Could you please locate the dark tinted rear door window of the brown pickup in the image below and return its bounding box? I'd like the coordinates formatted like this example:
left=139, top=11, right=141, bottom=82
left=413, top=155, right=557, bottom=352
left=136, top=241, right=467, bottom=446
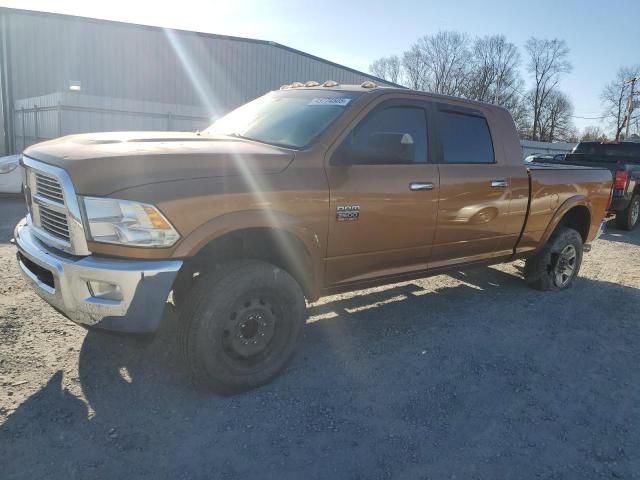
left=438, top=112, right=495, bottom=163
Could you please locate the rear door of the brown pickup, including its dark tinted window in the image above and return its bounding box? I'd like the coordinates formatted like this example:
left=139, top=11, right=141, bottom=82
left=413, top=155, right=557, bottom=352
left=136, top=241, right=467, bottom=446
left=429, top=104, right=510, bottom=268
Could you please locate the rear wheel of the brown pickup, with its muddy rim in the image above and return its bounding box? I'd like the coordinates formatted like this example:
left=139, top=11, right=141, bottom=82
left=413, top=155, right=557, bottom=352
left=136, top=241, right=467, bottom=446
left=524, top=226, right=583, bottom=291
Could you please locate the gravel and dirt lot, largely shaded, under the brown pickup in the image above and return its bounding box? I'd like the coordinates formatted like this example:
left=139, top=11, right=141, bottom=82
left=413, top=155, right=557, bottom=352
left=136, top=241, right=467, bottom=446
left=0, top=198, right=640, bottom=479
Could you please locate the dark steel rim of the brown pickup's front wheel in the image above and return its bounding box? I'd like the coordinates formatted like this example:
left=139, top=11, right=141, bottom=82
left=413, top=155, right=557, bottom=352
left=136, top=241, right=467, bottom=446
left=222, top=295, right=279, bottom=365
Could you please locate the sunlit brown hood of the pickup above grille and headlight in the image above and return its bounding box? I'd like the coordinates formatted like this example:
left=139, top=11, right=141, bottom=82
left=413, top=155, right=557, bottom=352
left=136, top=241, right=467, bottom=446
left=24, top=132, right=294, bottom=195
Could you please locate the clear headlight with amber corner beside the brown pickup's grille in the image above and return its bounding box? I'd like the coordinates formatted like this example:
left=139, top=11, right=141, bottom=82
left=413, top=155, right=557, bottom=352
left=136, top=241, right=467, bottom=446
left=81, top=197, right=180, bottom=247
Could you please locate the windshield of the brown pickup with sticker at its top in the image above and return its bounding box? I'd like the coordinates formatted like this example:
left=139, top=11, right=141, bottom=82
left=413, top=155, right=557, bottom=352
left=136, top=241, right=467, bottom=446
left=203, top=90, right=361, bottom=148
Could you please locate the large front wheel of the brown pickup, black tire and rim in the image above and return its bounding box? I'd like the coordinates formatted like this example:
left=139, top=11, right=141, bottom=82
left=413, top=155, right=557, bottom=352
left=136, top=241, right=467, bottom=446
left=180, top=260, right=306, bottom=394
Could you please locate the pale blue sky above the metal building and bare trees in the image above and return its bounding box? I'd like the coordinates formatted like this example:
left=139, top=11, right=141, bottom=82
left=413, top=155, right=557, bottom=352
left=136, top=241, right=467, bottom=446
left=0, top=0, right=640, bottom=129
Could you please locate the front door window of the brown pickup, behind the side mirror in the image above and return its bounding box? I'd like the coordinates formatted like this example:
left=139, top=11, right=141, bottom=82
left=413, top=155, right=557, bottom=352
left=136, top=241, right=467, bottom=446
left=338, top=106, right=427, bottom=165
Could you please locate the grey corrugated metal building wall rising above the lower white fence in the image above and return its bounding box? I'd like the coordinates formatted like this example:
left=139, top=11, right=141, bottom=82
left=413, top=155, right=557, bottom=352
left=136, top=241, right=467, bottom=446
left=0, top=9, right=396, bottom=154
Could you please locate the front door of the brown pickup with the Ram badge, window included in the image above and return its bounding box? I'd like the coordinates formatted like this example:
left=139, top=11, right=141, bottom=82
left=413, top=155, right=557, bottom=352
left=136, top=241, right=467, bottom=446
left=326, top=100, right=439, bottom=286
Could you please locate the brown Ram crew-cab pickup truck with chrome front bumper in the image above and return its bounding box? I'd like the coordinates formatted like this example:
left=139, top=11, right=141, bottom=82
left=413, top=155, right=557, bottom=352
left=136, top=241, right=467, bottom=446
left=15, top=82, right=612, bottom=392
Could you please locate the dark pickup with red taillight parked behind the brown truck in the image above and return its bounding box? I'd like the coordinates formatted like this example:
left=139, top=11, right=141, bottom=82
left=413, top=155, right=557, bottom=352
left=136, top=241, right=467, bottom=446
left=534, top=142, right=640, bottom=230
